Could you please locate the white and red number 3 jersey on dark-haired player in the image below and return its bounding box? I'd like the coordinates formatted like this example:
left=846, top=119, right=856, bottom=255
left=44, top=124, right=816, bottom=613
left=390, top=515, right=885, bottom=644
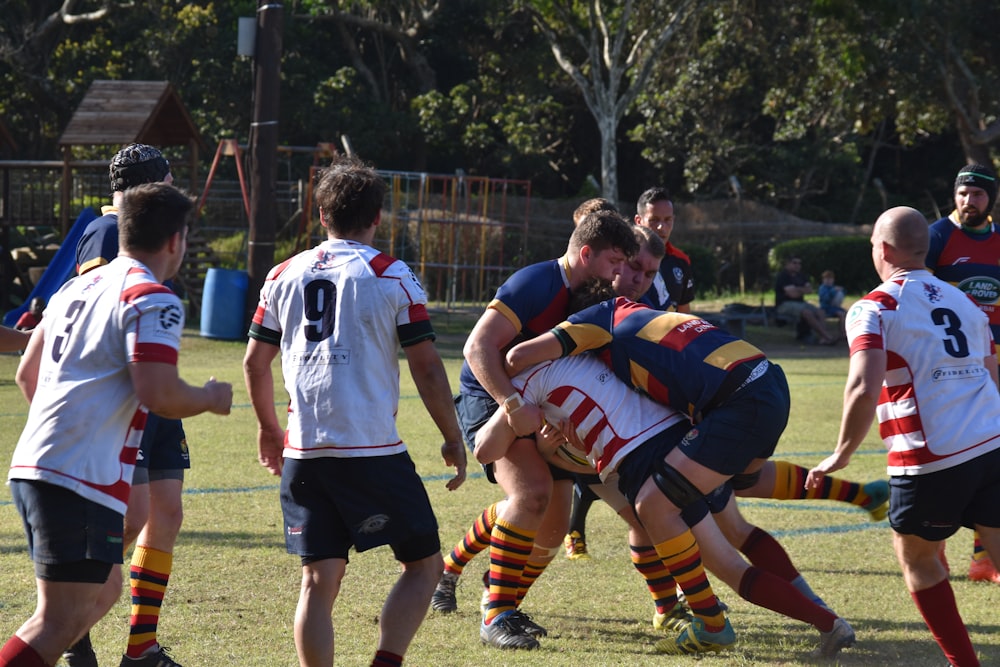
left=8, top=257, right=184, bottom=514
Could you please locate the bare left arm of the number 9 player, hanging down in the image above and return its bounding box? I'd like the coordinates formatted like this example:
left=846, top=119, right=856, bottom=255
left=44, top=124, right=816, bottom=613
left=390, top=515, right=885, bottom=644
left=243, top=338, right=285, bottom=475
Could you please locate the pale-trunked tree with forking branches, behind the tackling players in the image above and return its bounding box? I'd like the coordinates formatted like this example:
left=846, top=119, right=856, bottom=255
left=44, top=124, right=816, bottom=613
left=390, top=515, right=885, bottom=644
left=525, top=0, right=702, bottom=201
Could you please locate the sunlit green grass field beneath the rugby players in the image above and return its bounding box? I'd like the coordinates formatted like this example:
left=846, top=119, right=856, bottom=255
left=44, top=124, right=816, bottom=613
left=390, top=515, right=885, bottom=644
left=0, top=314, right=1000, bottom=667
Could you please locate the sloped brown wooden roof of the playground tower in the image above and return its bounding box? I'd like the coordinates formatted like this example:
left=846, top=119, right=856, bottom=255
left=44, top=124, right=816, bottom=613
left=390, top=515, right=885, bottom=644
left=59, top=80, right=205, bottom=150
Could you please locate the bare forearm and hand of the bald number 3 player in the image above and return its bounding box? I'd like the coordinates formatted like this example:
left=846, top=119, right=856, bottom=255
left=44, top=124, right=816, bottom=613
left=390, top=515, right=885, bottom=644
left=805, top=349, right=886, bottom=489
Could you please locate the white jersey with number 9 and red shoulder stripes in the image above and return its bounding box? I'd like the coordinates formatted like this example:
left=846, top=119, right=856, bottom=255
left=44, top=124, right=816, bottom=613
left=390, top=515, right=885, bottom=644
left=250, top=240, right=434, bottom=459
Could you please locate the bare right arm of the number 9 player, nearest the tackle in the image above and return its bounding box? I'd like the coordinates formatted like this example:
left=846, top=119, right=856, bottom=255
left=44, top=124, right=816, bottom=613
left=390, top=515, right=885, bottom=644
left=403, top=340, right=466, bottom=491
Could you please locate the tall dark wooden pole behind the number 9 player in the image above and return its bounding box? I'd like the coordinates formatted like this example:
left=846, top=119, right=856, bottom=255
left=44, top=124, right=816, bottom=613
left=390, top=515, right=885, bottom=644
left=246, top=0, right=283, bottom=330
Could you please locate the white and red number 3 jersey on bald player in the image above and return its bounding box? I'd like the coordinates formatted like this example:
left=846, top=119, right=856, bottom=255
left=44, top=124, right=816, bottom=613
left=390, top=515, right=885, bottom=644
left=847, top=270, right=1000, bottom=475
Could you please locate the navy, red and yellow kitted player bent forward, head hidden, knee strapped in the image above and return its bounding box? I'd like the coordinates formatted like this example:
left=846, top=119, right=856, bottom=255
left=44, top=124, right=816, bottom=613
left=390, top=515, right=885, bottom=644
left=507, top=286, right=853, bottom=656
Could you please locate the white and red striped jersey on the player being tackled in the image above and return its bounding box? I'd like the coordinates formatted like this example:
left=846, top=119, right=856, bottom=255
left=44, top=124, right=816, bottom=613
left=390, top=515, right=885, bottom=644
left=512, top=354, right=688, bottom=479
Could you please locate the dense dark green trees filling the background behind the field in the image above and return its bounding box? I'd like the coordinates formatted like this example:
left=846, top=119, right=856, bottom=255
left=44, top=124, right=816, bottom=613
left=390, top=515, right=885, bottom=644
left=0, top=0, right=1000, bottom=222
